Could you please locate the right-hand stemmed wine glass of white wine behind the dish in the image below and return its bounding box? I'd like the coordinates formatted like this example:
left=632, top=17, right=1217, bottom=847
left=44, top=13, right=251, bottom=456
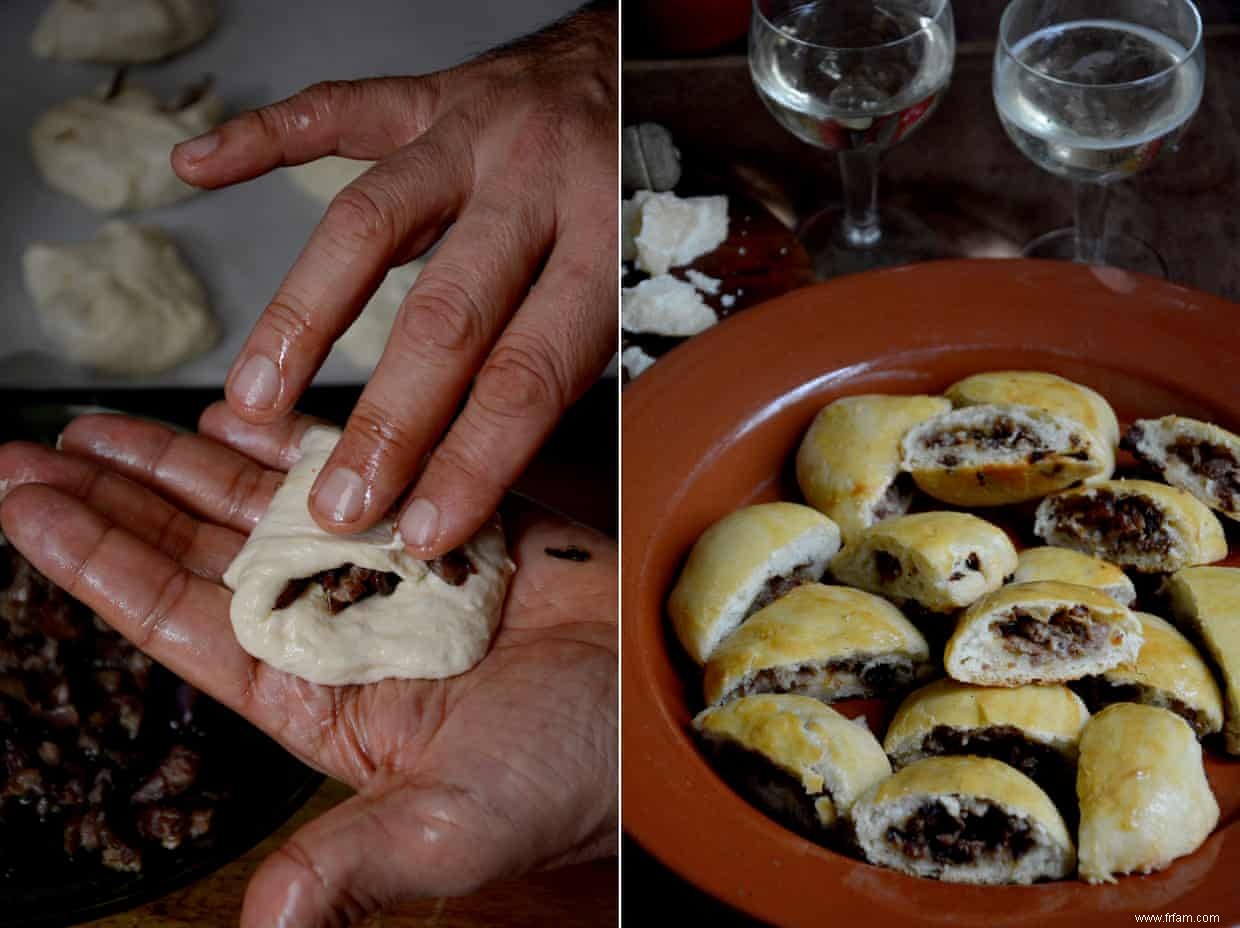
left=993, top=0, right=1205, bottom=277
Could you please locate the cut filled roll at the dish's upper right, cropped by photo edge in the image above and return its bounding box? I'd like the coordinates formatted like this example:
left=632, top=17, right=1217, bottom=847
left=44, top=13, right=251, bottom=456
left=1123, top=416, right=1240, bottom=520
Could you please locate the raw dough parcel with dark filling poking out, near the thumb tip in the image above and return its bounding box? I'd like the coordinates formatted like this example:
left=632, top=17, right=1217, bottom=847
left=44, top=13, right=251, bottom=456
left=30, top=78, right=223, bottom=210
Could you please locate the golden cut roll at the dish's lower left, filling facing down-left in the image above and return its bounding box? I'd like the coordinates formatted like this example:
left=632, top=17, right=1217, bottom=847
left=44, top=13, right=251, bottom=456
left=693, top=694, right=892, bottom=837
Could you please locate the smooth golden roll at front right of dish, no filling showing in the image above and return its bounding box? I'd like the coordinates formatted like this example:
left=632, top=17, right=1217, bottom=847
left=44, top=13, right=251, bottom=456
left=1076, top=702, right=1219, bottom=883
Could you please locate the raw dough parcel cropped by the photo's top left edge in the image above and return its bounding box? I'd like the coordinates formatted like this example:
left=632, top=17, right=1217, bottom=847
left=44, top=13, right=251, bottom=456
left=31, top=0, right=217, bottom=65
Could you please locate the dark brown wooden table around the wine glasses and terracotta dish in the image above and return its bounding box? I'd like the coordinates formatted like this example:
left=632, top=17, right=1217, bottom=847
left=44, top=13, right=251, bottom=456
left=621, top=16, right=1240, bottom=928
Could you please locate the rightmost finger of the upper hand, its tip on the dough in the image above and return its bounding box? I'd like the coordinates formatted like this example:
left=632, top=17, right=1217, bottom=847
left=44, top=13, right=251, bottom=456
left=398, top=234, right=616, bottom=557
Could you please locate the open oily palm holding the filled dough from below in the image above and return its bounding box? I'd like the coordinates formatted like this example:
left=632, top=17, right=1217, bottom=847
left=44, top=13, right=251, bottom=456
left=0, top=403, right=618, bottom=928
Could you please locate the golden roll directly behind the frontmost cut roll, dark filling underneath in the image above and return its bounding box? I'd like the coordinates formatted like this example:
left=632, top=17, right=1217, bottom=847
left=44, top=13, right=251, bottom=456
left=883, top=680, right=1089, bottom=799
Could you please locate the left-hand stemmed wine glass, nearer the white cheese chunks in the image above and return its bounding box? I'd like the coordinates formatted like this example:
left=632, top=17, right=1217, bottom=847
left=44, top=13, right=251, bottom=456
left=749, top=0, right=956, bottom=277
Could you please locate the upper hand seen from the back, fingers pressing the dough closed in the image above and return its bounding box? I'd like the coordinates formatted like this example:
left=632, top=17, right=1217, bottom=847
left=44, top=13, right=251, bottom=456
left=172, top=5, right=618, bottom=558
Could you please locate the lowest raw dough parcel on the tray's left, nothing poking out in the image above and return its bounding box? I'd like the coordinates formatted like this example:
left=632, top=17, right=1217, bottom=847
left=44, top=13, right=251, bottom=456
left=22, top=222, right=219, bottom=376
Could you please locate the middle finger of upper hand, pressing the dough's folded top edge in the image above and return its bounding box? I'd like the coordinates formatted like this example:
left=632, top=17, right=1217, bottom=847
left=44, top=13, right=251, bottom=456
left=310, top=179, right=553, bottom=531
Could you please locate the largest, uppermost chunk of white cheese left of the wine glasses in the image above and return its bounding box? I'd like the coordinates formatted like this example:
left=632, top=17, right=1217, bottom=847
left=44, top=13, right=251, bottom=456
left=634, top=194, right=728, bottom=274
